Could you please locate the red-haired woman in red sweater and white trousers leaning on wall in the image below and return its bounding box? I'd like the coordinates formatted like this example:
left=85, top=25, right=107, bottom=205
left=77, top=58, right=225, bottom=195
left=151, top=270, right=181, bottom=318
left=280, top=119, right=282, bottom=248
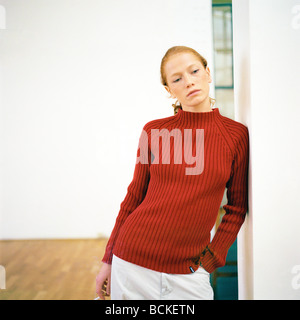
left=96, top=46, right=249, bottom=300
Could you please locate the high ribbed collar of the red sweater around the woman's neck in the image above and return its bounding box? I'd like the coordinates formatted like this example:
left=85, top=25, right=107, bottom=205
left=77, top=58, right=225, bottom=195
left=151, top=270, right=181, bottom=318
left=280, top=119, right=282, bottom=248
left=175, top=108, right=220, bottom=126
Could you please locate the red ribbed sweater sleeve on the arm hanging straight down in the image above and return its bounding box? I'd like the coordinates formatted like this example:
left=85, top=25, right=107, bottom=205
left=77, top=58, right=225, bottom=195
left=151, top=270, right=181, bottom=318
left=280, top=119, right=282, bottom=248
left=102, top=126, right=151, bottom=264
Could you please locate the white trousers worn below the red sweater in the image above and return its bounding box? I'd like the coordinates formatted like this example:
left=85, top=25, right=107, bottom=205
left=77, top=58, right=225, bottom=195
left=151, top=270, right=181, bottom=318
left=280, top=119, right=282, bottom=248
left=111, top=256, right=214, bottom=300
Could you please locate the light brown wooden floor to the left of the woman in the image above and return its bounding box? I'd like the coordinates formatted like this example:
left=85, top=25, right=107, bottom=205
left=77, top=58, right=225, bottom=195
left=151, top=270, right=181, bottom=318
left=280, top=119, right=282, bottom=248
left=0, top=239, right=107, bottom=300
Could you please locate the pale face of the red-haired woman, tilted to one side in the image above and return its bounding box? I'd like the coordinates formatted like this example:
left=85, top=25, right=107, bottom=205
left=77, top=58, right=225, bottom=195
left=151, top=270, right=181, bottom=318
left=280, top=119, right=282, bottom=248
left=164, top=52, right=212, bottom=111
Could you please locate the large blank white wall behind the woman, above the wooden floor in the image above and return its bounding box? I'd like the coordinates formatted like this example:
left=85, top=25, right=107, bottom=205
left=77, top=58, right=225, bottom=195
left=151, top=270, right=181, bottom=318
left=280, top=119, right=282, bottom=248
left=0, top=0, right=213, bottom=239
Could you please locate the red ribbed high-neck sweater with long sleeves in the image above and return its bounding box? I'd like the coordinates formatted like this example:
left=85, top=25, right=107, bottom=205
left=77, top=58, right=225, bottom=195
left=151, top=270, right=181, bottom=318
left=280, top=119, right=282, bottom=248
left=102, top=108, right=249, bottom=274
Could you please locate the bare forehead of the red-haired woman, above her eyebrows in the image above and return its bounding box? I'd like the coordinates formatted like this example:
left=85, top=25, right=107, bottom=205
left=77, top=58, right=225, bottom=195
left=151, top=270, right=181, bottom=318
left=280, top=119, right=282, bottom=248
left=165, top=52, right=202, bottom=77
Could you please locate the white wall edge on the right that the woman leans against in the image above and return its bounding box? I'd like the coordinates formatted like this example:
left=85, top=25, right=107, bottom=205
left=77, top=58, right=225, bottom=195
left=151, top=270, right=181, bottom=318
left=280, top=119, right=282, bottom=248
left=233, top=0, right=300, bottom=299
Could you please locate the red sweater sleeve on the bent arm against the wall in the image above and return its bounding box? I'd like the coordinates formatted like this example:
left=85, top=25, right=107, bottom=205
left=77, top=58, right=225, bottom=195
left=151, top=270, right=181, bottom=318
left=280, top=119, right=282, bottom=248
left=200, top=126, right=249, bottom=273
